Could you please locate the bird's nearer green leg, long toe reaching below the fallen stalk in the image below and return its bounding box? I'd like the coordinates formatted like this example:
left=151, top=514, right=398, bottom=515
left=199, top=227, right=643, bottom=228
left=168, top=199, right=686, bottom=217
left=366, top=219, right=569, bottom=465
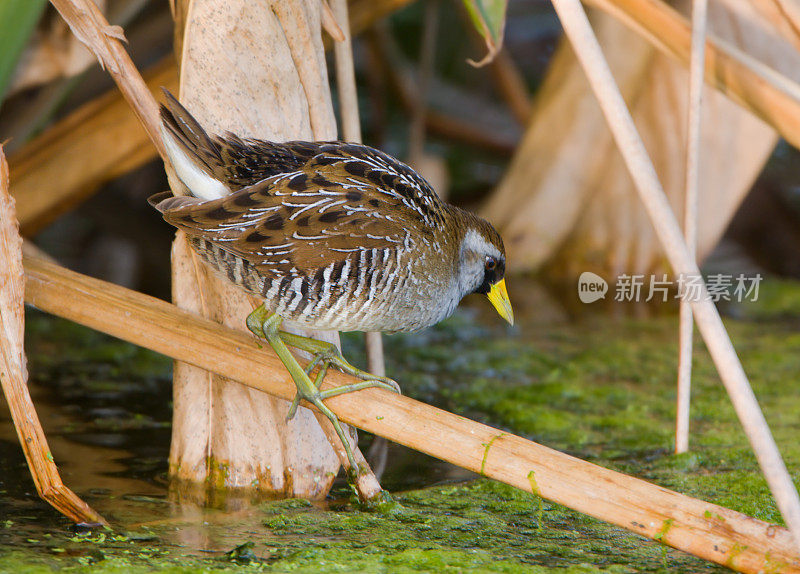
left=247, top=305, right=358, bottom=469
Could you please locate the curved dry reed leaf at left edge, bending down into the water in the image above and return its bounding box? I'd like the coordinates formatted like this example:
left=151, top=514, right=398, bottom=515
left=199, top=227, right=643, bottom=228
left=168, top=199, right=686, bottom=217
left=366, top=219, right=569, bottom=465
left=0, top=145, right=106, bottom=524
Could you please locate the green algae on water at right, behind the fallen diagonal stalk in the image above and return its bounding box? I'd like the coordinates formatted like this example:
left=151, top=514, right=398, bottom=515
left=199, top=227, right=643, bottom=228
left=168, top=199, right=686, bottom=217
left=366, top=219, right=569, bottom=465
left=412, top=310, right=800, bottom=523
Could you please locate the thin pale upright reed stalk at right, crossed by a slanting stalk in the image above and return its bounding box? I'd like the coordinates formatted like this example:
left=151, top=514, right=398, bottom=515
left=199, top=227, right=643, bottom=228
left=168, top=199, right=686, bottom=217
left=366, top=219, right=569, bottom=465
left=675, top=0, right=708, bottom=453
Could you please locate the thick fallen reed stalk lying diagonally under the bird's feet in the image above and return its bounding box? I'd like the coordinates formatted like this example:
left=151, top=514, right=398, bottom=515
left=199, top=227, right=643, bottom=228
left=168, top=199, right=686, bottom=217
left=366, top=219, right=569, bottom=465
left=24, top=257, right=800, bottom=573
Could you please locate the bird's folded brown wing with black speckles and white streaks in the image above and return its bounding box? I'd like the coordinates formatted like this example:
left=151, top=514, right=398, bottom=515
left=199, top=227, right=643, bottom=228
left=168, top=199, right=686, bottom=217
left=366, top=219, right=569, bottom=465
left=153, top=143, right=443, bottom=276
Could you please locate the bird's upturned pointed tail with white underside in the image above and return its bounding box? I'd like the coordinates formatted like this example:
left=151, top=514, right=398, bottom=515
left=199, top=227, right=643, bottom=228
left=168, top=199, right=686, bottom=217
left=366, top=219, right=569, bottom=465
left=161, top=88, right=231, bottom=200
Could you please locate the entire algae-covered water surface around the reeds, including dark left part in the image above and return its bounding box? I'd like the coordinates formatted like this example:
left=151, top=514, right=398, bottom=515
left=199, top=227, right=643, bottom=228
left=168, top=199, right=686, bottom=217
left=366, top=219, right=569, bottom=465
left=0, top=278, right=800, bottom=572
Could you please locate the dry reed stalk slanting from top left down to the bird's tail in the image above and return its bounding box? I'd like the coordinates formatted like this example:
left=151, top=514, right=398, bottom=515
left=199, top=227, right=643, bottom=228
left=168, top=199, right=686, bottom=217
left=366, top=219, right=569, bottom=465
left=50, top=0, right=166, bottom=158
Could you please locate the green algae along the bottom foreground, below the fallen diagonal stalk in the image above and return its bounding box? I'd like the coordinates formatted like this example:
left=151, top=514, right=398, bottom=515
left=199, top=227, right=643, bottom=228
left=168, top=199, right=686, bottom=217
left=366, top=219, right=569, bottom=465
left=0, top=480, right=705, bottom=573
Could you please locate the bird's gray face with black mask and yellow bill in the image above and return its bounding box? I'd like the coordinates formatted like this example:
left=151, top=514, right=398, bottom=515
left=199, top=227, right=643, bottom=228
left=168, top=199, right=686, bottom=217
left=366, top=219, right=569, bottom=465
left=457, top=229, right=514, bottom=325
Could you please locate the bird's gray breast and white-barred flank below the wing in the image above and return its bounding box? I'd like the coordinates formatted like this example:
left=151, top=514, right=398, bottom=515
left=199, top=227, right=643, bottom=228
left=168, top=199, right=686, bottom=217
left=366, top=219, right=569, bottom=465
left=192, top=235, right=460, bottom=332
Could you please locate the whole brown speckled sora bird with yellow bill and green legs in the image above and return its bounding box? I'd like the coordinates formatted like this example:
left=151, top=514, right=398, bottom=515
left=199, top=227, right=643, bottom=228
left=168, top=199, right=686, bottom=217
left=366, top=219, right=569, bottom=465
left=150, top=90, right=513, bottom=469
